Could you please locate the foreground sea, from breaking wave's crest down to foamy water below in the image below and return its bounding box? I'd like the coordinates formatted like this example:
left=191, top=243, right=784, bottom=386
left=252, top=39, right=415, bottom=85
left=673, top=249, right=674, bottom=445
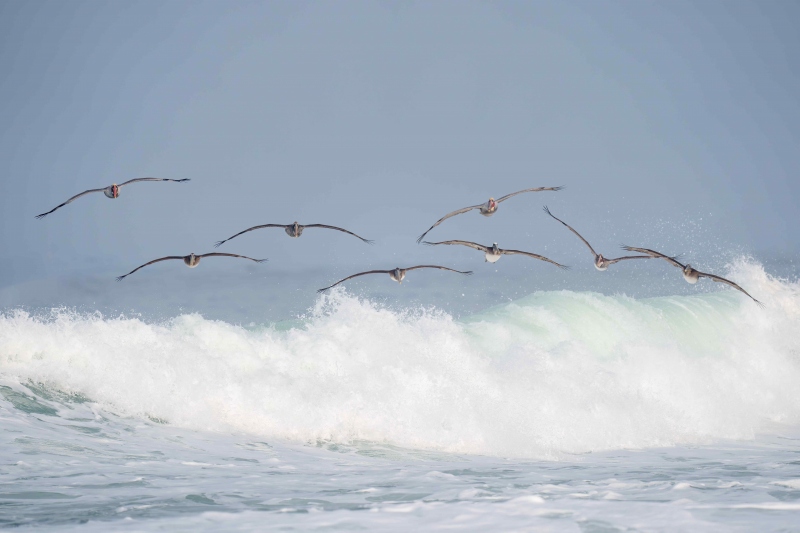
left=0, top=260, right=800, bottom=532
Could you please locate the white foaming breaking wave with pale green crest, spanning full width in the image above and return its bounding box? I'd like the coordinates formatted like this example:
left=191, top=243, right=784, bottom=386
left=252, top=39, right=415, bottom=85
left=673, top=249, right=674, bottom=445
left=0, top=261, right=800, bottom=458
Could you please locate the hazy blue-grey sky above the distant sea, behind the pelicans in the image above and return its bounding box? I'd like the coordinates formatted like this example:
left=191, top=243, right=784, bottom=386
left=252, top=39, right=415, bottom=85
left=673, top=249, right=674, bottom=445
left=0, top=0, right=800, bottom=285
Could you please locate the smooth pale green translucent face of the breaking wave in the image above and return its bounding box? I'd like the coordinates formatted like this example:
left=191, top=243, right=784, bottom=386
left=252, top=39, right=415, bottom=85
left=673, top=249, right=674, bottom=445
left=465, top=291, right=743, bottom=358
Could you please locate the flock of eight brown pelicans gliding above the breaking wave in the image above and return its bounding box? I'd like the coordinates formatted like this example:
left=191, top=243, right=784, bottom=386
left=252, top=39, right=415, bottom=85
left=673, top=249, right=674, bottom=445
left=31, top=178, right=763, bottom=307
